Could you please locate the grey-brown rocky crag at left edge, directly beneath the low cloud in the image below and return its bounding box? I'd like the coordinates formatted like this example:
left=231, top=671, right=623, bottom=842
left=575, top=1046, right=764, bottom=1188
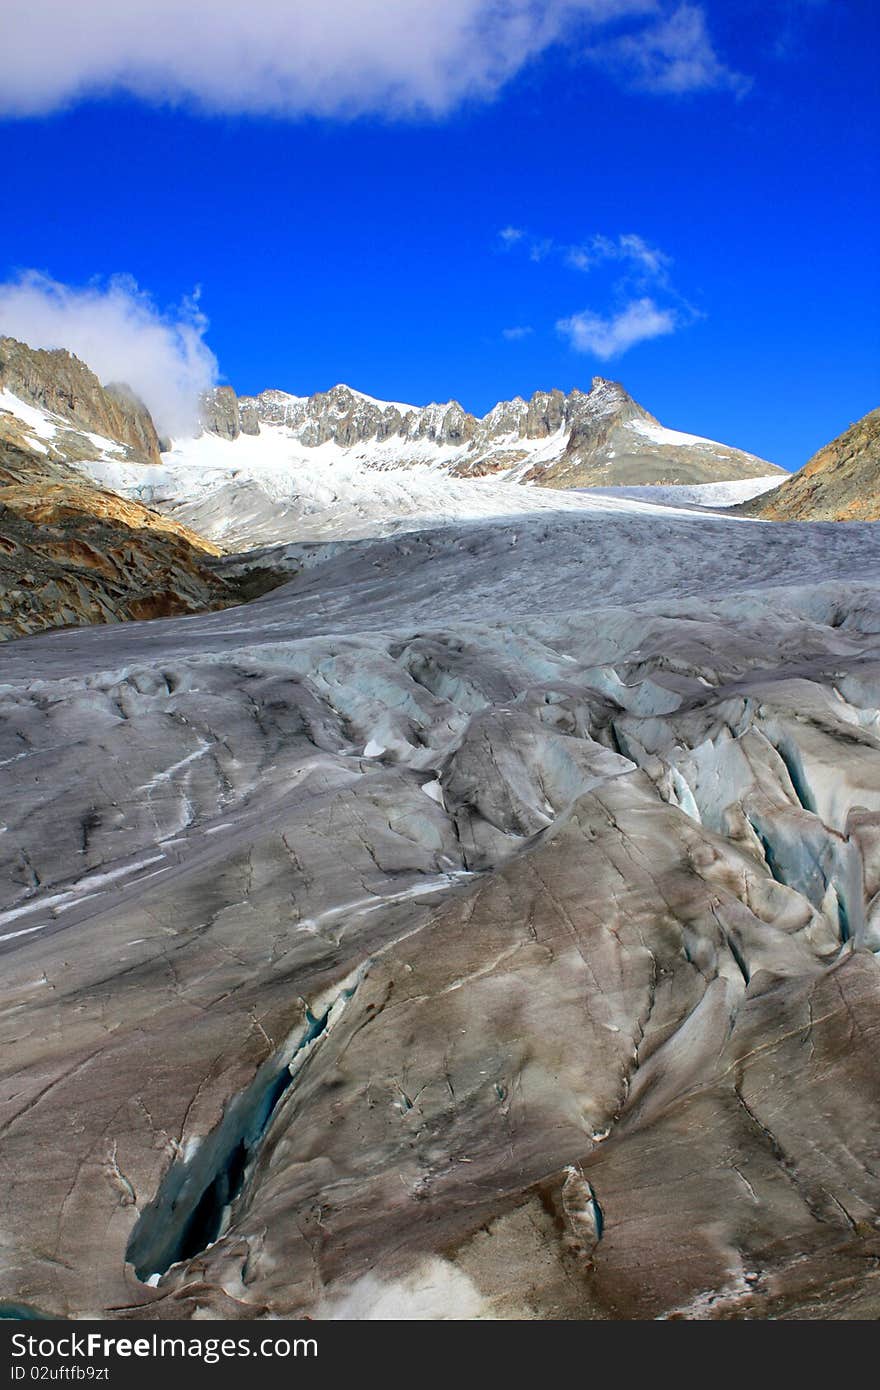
left=0, top=338, right=160, bottom=463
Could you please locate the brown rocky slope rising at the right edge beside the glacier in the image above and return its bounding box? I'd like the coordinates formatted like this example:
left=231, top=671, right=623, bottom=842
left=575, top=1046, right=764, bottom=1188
left=738, top=410, right=880, bottom=521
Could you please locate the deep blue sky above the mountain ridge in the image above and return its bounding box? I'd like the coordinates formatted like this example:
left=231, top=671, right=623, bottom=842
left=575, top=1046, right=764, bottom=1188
left=0, top=0, right=880, bottom=468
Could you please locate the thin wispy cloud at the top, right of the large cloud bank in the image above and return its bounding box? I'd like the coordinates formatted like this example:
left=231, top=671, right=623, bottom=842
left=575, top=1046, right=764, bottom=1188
left=591, top=4, right=751, bottom=96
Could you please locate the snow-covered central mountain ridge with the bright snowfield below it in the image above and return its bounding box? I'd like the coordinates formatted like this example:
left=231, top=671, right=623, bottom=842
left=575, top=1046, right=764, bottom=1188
left=61, top=379, right=781, bottom=549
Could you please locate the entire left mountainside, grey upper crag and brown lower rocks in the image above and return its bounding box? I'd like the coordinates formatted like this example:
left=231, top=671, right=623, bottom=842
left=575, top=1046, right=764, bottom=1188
left=0, top=338, right=298, bottom=641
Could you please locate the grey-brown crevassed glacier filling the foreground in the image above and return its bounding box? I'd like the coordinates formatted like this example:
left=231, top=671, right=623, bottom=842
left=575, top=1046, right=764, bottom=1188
left=0, top=482, right=880, bottom=1319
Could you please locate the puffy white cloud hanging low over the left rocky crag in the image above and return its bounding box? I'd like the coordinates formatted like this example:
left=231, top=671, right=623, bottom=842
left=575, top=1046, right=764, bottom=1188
left=0, top=271, right=217, bottom=435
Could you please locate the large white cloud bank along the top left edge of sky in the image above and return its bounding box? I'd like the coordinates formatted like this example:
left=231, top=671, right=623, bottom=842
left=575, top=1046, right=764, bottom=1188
left=0, top=0, right=658, bottom=117
